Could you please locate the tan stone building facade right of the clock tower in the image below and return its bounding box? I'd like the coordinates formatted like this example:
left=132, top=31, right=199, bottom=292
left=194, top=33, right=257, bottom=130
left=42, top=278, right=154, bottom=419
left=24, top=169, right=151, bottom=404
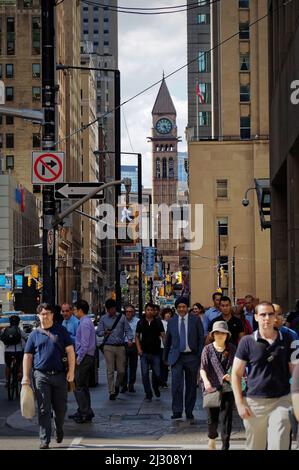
left=187, top=0, right=271, bottom=305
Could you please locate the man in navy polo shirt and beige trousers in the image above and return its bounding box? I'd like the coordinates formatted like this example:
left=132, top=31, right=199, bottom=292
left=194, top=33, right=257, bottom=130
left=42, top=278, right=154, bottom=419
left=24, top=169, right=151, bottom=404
left=232, top=302, right=294, bottom=450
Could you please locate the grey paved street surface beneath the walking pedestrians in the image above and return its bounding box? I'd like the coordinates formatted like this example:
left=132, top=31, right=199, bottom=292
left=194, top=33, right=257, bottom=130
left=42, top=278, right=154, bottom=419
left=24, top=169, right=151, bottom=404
left=0, top=354, right=248, bottom=449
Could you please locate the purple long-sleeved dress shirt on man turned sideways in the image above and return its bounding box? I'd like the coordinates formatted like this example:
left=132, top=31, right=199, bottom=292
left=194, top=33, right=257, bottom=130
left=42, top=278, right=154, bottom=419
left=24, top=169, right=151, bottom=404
left=75, top=315, right=96, bottom=364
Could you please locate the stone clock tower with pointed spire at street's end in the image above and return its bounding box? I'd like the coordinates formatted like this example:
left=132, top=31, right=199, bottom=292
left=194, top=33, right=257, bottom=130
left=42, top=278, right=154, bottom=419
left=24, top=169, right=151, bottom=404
left=150, top=77, right=179, bottom=274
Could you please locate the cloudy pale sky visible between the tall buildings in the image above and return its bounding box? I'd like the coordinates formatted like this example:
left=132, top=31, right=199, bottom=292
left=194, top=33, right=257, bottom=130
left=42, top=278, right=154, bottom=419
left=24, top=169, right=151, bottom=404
left=118, top=0, right=187, bottom=187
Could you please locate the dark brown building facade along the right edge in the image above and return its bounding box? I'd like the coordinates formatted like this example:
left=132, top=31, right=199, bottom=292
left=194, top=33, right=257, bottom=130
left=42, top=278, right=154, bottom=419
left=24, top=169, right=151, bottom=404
left=268, top=0, right=299, bottom=311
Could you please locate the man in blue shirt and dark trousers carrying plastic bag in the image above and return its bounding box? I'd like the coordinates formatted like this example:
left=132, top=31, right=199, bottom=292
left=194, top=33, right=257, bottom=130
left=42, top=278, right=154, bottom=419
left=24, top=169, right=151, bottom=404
left=22, top=303, right=75, bottom=449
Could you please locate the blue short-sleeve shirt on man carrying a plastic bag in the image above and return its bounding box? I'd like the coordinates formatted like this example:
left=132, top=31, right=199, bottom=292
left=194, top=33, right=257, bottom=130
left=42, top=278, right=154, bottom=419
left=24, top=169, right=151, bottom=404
left=24, top=323, right=73, bottom=372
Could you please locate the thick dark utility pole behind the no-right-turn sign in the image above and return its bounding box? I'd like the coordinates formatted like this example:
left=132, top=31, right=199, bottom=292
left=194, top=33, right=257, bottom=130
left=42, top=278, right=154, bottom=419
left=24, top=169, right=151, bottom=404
left=41, top=0, right=55, bottom=305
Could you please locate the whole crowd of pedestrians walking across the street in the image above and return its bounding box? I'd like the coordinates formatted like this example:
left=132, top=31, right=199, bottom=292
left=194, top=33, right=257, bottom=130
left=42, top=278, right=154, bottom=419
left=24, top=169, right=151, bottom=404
left=1, top=292, right=299, bottom=450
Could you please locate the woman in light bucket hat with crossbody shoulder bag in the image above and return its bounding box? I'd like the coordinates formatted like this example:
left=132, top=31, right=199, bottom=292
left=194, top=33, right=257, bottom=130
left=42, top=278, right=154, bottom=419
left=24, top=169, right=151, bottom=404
left=200, top=321, right=236, bottom=450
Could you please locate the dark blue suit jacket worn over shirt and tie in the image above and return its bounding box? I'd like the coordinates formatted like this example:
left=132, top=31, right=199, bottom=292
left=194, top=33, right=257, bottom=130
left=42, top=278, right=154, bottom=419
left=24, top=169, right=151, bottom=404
left=163, top=313, right=204, bottom=366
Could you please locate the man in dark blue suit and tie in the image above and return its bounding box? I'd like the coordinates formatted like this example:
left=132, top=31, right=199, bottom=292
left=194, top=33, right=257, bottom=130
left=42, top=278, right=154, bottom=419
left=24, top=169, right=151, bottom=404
left=164, top=297, right=204, bottom=420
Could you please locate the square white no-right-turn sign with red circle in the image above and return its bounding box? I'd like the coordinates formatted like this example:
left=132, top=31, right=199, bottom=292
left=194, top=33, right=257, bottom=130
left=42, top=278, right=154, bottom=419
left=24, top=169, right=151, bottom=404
left=32, top=152, right=64, bottom=184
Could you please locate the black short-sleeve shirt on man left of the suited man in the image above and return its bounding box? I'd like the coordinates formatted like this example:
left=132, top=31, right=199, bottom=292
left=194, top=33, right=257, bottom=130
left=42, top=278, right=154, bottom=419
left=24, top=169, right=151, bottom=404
left=136, top=317, right=164, bottom=354
